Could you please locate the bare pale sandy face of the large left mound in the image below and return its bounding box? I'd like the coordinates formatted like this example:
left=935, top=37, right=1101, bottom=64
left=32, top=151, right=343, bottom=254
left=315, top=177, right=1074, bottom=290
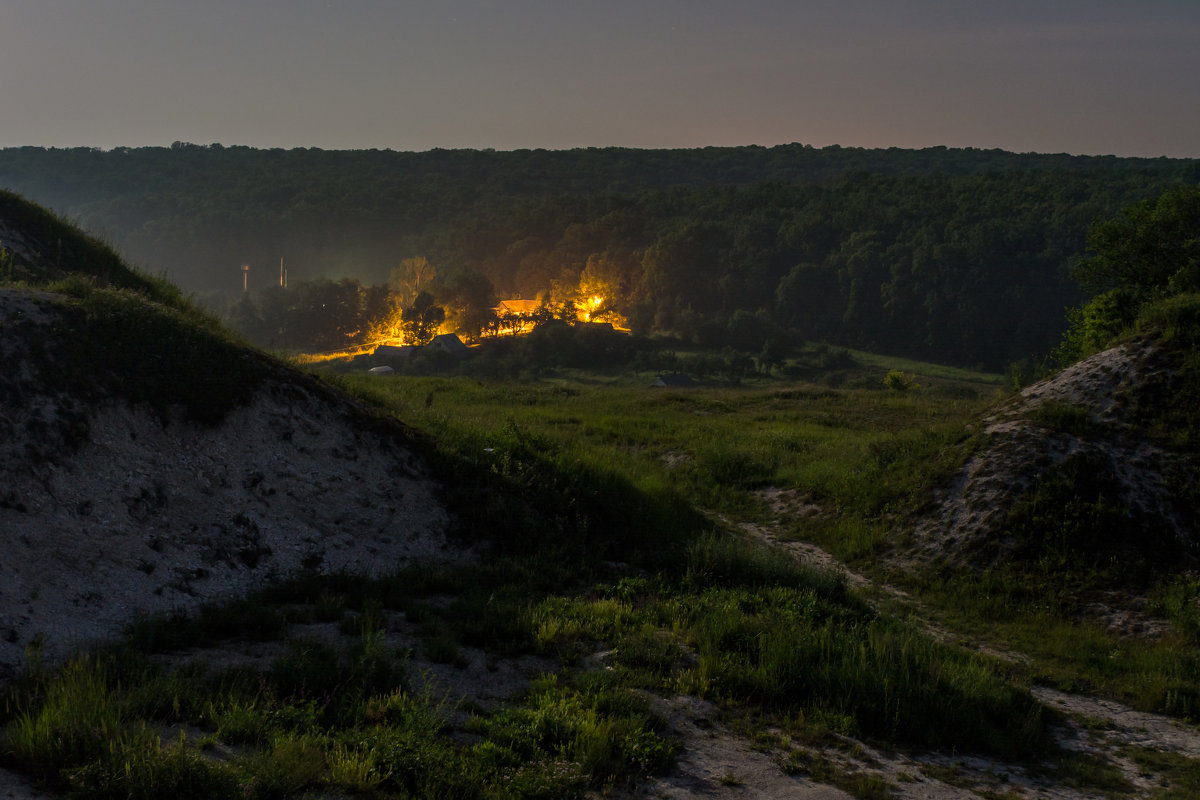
left=0, top=290, right=458, bottom=679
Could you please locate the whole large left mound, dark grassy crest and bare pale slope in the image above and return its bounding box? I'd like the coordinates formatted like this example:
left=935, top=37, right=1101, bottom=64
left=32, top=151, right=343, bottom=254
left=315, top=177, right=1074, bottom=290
left=0, top=194, right=458, bottom=678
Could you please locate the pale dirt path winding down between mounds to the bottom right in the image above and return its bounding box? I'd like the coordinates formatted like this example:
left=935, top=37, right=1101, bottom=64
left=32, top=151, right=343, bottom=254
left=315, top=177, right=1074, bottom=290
left=662, top=506, right=1200, bottom=800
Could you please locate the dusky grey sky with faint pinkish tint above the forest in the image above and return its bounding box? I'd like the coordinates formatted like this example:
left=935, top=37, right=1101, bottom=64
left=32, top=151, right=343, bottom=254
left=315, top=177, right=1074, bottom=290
left=0, top=0, right=1200, bottom=157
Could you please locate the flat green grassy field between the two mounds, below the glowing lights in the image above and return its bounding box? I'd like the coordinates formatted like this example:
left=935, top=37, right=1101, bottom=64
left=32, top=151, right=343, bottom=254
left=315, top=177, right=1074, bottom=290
left=343, top=354, right=1001, bottom=558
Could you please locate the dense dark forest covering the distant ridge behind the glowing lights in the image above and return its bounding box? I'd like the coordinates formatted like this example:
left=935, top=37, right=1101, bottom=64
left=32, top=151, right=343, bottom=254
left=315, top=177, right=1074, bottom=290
left=0, top=143, right=1200, bottom=368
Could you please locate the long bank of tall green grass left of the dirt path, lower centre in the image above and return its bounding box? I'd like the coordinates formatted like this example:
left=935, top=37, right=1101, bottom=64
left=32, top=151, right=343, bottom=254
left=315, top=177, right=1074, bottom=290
left=532, top=536, right=1052, bottom=759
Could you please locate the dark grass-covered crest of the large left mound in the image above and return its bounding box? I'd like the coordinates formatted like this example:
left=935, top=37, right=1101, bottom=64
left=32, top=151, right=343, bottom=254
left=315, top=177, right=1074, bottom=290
left=0, top=192, right=302, bottom=433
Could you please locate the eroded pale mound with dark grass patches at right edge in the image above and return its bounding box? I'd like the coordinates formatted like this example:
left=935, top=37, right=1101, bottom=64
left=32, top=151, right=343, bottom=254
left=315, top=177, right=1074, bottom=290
left=920, top=337, right=1200, bottom=587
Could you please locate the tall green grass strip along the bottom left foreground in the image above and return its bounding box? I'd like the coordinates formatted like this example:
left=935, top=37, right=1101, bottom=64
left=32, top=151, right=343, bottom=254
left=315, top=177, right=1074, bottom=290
left=0, top=644, right=674, bottom=799
